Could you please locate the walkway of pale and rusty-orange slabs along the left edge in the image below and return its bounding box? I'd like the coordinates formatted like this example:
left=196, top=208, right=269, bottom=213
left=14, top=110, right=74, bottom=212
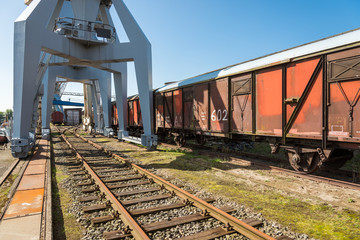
left=0, top=140, right=50, bottom=240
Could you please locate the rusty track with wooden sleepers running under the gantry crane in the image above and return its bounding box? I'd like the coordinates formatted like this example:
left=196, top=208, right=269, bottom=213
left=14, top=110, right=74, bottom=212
left=58, top=126, right=291, bottom=239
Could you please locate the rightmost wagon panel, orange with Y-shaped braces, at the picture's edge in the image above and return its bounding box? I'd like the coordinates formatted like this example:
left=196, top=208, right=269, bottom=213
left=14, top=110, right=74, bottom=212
left=327, top=48, right=360, bottom=141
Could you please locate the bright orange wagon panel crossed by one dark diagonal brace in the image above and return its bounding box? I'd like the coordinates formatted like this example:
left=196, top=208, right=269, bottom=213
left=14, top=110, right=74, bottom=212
left=283, top=58, right=323, bottom=139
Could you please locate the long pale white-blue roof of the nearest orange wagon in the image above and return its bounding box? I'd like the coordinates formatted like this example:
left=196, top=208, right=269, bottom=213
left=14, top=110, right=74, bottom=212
left=156, top=28, right=360, bottom=92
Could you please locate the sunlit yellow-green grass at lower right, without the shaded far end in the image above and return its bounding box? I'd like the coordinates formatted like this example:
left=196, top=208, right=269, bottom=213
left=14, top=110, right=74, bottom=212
left=170, top=169, right=360, bottom=240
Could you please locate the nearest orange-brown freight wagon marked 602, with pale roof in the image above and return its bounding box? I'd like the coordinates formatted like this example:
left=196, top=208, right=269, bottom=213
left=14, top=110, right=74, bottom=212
left=112, top=29, right=360, bottom=173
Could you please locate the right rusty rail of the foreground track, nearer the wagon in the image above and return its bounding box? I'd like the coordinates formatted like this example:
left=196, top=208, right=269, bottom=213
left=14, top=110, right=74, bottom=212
left=74, top=132, right=276, bottom=240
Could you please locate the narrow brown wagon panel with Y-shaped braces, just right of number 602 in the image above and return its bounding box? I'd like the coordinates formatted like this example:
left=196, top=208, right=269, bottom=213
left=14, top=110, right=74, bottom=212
left=231, top=74, right=252, bottom=134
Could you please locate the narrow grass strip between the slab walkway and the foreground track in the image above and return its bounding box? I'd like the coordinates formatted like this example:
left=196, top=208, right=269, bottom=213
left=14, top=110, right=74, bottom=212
left=52, top=167, right=82, bottom=240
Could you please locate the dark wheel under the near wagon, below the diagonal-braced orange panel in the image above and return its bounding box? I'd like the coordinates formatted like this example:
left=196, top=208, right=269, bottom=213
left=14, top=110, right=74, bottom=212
left=286, top=151, right=320, bottom=174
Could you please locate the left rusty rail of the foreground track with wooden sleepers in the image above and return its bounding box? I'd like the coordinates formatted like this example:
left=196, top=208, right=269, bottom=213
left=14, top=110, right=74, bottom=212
left=57, top=126, right=150, bottom=240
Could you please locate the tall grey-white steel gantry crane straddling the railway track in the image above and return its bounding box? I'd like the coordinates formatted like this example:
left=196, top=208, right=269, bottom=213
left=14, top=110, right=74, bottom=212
left=11, top=0, right=157, bottom=158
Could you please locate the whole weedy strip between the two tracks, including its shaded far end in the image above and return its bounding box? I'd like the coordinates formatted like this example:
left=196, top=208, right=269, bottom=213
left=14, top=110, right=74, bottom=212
left=109, top=142, right=360, bottom=240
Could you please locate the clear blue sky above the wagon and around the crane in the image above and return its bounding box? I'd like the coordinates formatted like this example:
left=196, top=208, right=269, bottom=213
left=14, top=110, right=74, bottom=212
left=0, top=0, right=360, bottom=111
